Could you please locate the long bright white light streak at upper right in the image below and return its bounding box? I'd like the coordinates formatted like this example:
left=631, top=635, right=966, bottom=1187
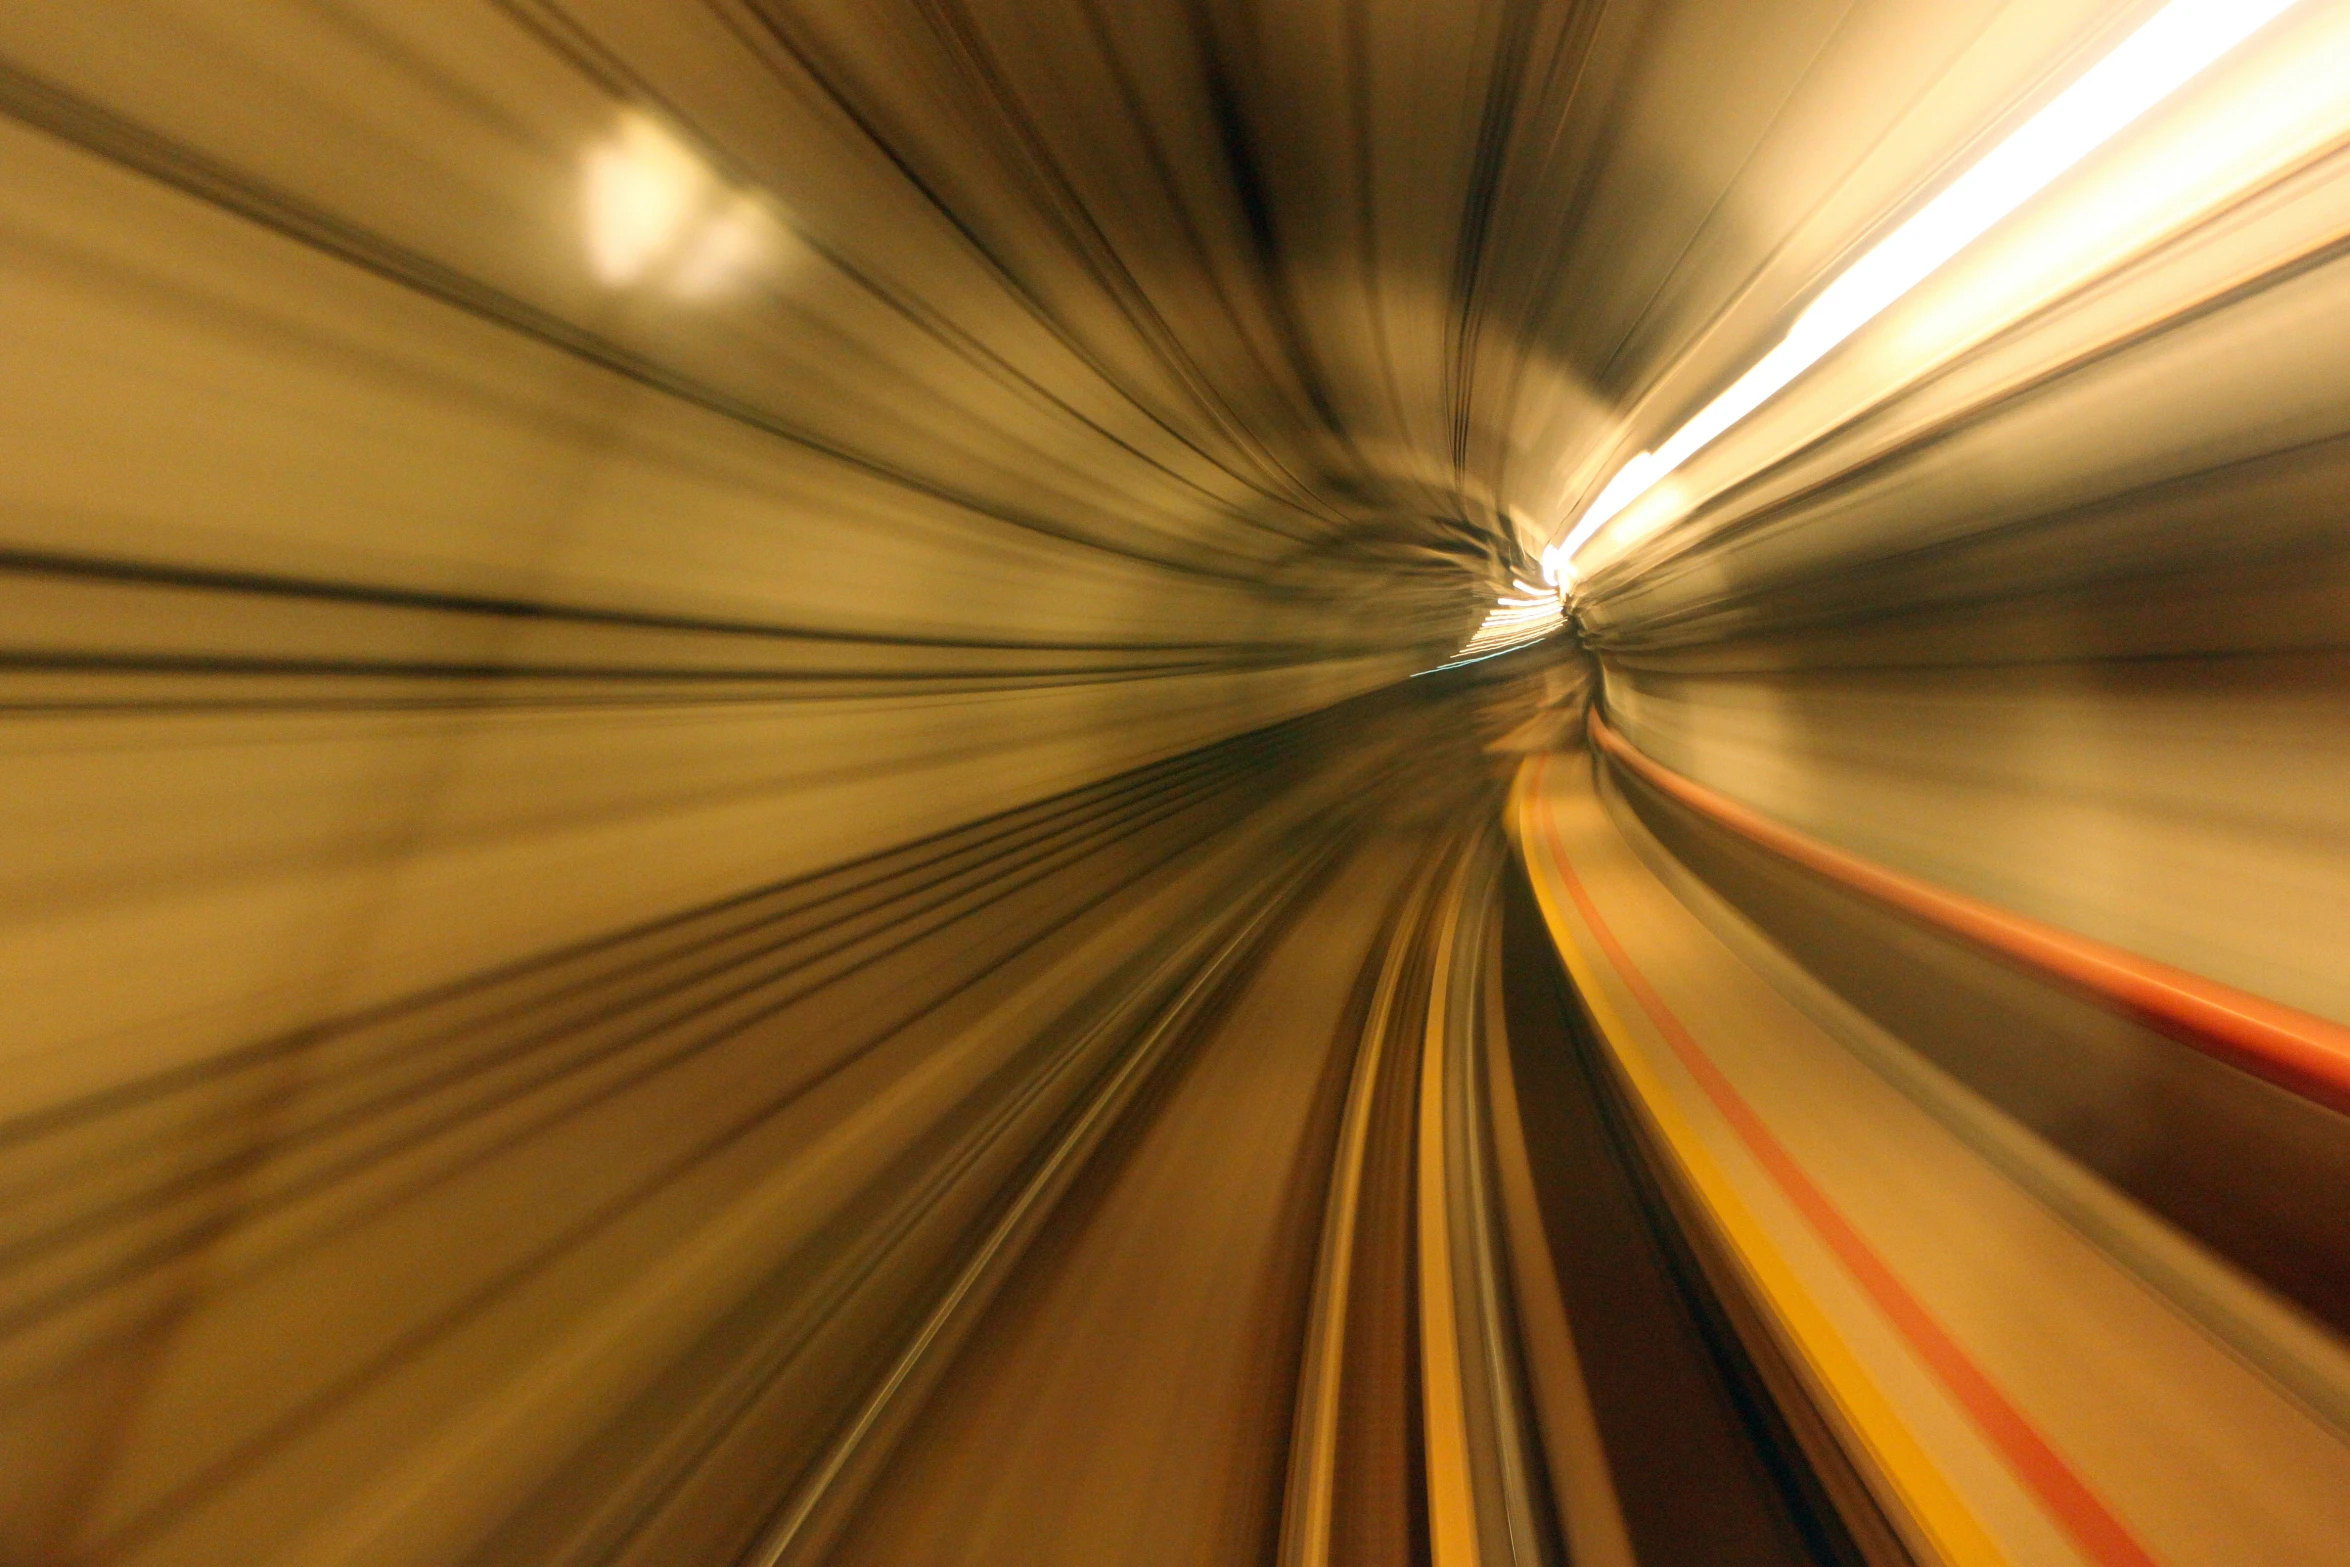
left=1542, top=0, right=2296, bottom=590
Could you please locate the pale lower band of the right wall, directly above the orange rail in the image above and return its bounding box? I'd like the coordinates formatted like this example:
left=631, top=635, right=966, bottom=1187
left=1610, top=658, right=2350, bottom=1020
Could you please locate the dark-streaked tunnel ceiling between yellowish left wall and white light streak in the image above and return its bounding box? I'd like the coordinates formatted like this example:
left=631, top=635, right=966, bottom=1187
left=601, top=0, right=2180, bottom=630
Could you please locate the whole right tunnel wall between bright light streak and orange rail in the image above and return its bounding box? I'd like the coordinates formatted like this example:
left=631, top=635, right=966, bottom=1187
left=1584, top=186, right=2350, bottom=1020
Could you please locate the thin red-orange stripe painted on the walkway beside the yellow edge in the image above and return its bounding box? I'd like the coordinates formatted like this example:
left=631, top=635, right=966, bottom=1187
left=1551, top=751, right=2155, bottom=1567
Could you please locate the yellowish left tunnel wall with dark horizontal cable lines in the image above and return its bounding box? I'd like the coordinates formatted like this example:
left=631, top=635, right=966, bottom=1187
left=0, top=7, right=1466, bottom=1107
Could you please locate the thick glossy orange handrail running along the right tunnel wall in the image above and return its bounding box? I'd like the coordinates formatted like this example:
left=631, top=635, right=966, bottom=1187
left=1591, top=707, right=2350, bottom=1114
